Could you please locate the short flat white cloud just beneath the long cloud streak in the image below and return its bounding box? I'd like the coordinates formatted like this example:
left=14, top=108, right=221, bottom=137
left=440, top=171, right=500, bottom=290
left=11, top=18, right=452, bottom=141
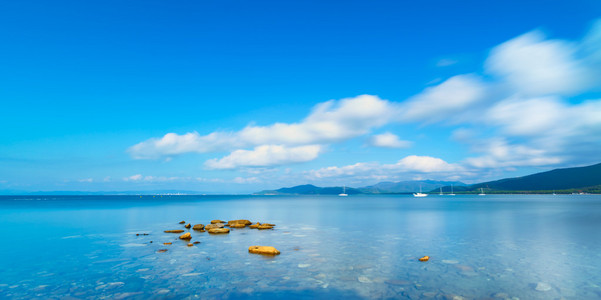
left=205, top=145, right=322, bottom=169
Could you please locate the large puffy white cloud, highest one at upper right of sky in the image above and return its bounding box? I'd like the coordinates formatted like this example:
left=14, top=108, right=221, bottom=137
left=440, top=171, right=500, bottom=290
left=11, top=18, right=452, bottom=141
left=485, top=31, right=593, bottom=96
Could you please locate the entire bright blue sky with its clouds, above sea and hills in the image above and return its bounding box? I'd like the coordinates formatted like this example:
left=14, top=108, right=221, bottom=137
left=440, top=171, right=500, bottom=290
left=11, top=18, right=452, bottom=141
left=0, top=0, right=601, bottom=193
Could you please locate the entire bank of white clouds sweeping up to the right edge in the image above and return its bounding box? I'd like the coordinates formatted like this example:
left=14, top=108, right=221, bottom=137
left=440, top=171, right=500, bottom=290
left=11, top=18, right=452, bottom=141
left=128, top=22, right=601, bottom=180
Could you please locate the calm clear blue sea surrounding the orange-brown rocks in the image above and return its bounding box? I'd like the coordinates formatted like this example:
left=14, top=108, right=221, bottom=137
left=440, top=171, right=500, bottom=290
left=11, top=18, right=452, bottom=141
left=0, top=195, right=601, bottom=299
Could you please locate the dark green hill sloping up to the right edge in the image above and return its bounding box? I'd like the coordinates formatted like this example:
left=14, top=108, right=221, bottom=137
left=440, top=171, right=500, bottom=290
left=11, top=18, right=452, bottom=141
left=469, top=163, right=601, bottom=192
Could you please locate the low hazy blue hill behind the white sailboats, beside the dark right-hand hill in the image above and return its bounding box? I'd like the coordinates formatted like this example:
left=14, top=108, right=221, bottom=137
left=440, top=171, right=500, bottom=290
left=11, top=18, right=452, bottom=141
left=359, top=180, right=466, bottom=194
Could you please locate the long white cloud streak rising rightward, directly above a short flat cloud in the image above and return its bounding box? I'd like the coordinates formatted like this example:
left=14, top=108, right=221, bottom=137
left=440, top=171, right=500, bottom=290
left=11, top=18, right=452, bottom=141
left=128, top=95, right=398, bottom=159
